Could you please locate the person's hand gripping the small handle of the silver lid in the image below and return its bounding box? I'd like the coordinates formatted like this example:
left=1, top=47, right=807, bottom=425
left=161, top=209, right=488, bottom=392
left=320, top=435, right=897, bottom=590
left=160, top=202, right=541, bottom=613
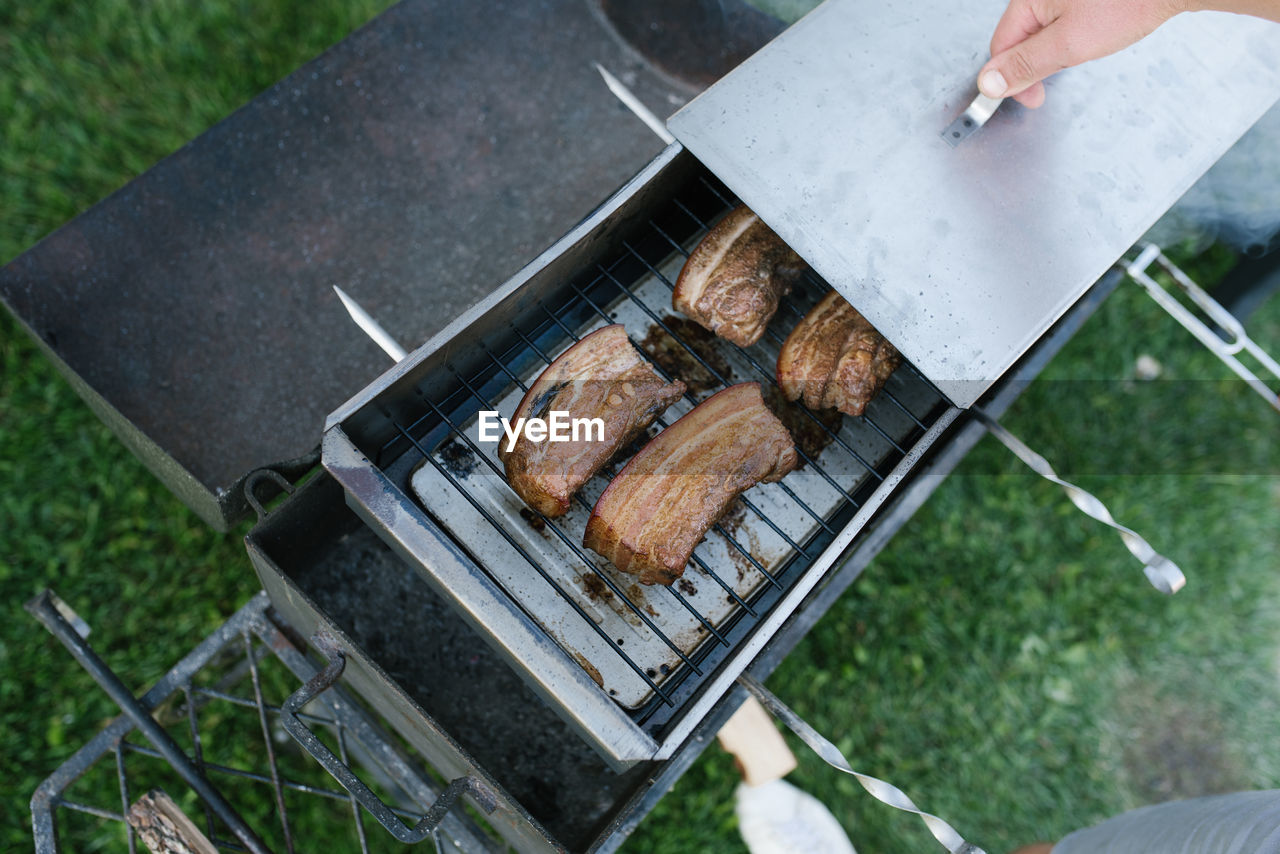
left=978, top=0, right=1188, bottom=108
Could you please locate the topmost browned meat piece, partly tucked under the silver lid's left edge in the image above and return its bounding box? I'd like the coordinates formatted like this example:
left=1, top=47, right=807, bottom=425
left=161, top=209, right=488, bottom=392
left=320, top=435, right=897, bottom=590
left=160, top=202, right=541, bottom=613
left=671, top=205, right=805, bottom=347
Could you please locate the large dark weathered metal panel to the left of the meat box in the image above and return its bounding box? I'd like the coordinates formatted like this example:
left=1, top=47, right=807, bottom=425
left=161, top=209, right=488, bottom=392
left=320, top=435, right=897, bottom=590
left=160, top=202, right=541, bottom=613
left=0, top=0, right=781, bottom=526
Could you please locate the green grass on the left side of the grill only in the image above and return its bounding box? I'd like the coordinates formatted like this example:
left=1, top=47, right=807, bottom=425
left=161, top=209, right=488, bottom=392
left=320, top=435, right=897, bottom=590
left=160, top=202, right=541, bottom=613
left=0, top=0, right=389, bottom=850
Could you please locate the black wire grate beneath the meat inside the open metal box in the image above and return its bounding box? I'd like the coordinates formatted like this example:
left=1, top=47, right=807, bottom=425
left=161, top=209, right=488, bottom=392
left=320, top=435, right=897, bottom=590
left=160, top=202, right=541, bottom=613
left=371, top=174, right=947, bottom=732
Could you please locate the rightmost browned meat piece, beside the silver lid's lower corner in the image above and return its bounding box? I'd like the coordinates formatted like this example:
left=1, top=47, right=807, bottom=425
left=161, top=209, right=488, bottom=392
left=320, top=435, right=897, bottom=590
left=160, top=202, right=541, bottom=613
left=777, top=291, right=902, bottom=415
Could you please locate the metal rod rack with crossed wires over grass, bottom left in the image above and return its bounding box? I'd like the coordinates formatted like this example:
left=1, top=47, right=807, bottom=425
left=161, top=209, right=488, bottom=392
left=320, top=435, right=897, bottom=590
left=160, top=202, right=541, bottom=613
left=31, top=593, right=500, bottom=854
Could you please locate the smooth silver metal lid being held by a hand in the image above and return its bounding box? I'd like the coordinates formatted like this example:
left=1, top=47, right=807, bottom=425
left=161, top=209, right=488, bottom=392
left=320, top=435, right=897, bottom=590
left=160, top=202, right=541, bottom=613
left=668, top=0, right=1280, bottom=406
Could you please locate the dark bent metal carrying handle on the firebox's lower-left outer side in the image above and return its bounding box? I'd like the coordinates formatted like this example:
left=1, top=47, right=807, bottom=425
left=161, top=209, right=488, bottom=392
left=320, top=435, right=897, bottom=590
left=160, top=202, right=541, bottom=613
left=280, top=635, right=497, bottom=845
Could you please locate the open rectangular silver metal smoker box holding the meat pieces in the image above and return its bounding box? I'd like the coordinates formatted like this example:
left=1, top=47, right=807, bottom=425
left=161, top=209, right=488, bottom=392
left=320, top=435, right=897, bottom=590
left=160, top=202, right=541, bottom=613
left=324, top=146, right=956, bottom=768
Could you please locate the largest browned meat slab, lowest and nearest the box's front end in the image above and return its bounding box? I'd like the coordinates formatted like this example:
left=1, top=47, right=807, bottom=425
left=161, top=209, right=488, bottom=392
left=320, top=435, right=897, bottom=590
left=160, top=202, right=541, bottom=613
left=582, top=383, right=796, bottom=584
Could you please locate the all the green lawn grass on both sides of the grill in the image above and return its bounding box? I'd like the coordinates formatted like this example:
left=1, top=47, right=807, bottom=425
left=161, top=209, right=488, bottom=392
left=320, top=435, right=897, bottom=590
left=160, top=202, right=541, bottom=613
left=0, top=0, right=1280, bottom=854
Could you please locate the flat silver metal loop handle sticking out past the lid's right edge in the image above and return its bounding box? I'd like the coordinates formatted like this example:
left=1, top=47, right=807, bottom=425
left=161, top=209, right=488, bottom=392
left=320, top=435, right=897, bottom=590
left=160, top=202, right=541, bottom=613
left=1125, top=243, right=1280, bottom=412
